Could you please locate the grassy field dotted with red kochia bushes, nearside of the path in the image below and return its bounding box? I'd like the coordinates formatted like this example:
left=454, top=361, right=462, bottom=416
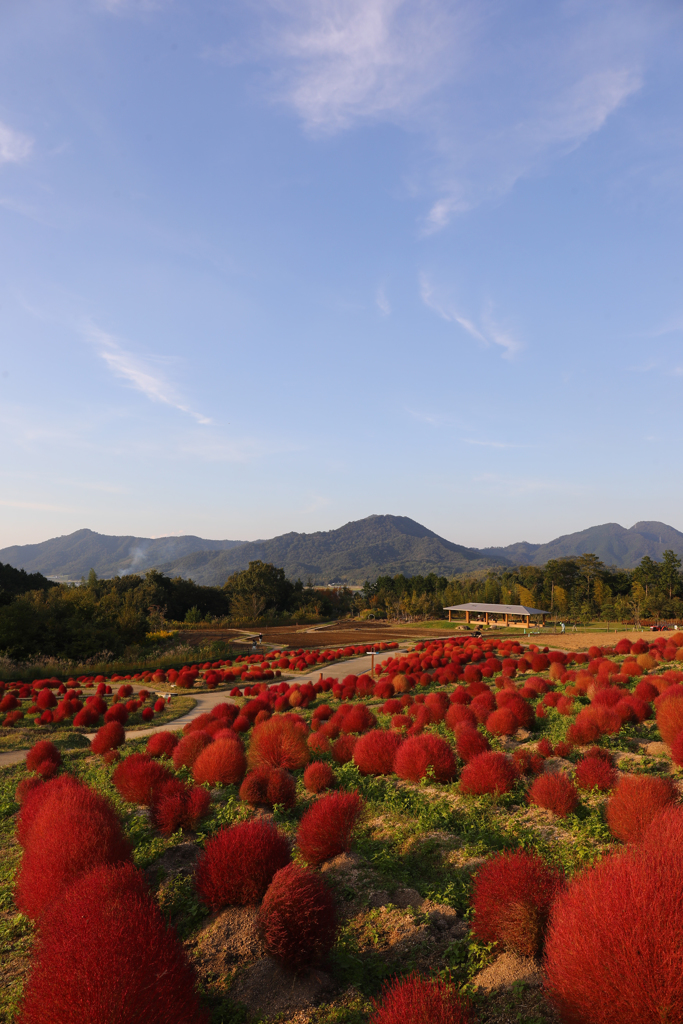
left=0, top=634, right=683, bottom=1024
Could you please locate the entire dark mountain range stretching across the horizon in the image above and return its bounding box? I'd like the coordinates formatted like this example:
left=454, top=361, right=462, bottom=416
left=0, top=515, right=683, bottom=586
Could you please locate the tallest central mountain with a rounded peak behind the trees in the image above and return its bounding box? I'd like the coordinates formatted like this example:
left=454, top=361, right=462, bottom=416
left=153, top=515, right=510, bottom=585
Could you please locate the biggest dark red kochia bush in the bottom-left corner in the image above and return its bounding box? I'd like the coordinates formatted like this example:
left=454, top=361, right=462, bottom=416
left=17, top=864, right=207, bottom=1024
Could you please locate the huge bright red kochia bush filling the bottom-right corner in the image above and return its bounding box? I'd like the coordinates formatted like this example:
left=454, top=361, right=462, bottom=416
left=545, top=812, right=683, bottom=1024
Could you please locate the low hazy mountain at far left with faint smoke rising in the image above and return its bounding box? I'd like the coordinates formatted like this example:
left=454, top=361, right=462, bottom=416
left=0, top=529, right=242, bottom=580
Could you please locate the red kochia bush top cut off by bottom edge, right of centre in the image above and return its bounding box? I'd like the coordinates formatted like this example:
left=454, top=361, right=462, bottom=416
left=370, top=973, right=470, bottom=1024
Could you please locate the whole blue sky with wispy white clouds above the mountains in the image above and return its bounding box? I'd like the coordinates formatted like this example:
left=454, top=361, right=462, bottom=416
left=0, top=0, right=683, bottom=547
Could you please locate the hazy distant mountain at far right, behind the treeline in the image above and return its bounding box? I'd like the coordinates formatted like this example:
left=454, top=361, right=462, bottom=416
left=479, top=522, right=683, bottom=569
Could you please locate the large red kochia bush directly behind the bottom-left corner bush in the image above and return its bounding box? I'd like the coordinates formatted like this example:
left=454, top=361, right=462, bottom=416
left=14, top=779, right=130, bottom=920
